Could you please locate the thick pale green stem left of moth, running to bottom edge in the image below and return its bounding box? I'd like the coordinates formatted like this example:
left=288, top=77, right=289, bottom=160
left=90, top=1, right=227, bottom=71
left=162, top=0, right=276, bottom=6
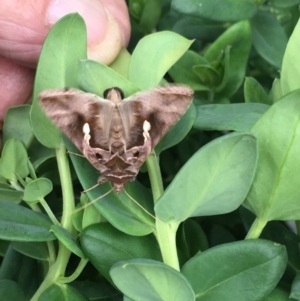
left=31, top=144, right=75, bottom=301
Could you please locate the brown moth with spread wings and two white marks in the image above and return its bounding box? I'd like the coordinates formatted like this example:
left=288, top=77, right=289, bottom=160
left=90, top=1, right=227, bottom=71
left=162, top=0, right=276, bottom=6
left=39, top=85, right=193, bottom=193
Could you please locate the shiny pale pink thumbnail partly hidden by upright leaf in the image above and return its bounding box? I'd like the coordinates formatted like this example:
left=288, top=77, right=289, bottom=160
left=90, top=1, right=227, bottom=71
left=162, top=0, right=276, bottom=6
left=46, top=0, right=107, bottom=45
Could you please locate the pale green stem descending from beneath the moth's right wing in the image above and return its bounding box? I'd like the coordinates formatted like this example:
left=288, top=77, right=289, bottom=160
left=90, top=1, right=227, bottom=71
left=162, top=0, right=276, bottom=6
left=146, top=152, right=179, bottom=270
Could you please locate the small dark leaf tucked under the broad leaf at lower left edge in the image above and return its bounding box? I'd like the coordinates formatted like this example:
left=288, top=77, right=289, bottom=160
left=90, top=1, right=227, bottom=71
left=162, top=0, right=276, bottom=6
left=11, top=241, right=49, bottom=260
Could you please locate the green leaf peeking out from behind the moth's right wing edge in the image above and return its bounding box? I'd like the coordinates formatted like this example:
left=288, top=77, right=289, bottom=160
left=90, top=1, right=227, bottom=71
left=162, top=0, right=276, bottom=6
left=155, top=104, right=197, bottom=155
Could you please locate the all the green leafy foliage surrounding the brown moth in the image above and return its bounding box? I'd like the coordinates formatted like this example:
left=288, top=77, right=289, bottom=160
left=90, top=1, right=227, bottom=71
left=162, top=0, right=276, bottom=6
left=0, top=0, right=300, bottom=301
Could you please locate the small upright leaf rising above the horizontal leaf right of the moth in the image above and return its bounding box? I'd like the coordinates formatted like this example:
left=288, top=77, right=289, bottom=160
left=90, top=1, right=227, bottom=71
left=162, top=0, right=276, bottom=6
left=244, top=77, right=272, bottom=104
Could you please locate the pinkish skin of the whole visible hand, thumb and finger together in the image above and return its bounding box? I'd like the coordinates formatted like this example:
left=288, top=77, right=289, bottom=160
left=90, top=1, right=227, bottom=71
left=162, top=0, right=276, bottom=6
left=0, top=0, right=130, bottom=127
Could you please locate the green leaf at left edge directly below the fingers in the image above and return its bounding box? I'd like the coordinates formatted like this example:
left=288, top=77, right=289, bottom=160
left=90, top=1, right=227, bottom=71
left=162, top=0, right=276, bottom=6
left=3, top=105, right=34, bottom=148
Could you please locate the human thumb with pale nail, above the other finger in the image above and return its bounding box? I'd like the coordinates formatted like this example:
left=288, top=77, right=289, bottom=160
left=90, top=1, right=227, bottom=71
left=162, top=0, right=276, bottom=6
left=0, top=0, right=130, bottom=67
